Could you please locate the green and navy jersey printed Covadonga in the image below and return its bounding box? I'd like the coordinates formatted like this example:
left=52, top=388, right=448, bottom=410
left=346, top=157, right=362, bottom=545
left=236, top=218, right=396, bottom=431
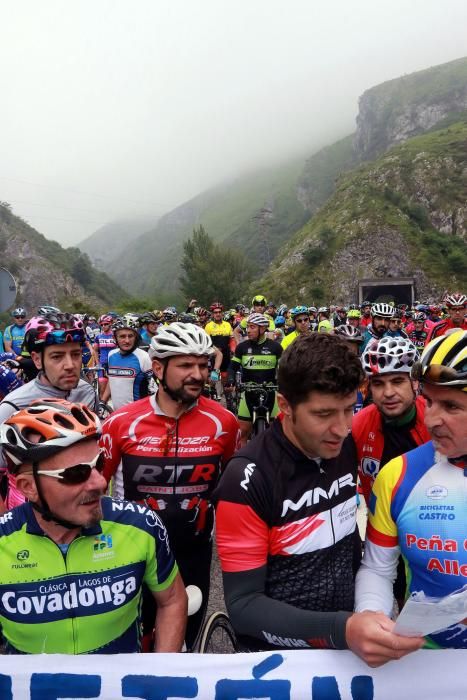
left=0, top=498, right=177, bottom=654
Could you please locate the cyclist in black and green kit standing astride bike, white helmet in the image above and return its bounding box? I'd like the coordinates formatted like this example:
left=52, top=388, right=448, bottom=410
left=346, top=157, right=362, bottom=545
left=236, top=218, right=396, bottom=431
left=228, top=313, right=282, bottom=445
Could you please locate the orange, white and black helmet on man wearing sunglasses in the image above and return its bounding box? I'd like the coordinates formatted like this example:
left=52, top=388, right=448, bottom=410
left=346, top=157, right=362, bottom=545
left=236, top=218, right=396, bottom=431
left=0, top=399, right=101, bottom=473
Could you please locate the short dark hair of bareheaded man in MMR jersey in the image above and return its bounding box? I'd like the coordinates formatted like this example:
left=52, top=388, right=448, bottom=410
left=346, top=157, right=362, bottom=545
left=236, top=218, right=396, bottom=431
left=278, top=333, right=365, bottom=406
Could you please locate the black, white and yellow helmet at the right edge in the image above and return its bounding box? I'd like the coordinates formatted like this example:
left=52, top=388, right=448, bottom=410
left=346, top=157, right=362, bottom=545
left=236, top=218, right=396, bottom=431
left=412, top=329, right=467, bottom=391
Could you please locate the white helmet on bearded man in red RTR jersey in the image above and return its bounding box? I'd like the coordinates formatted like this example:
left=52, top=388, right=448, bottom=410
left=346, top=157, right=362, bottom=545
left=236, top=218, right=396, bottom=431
left=148, top=321, right=215, bottom=360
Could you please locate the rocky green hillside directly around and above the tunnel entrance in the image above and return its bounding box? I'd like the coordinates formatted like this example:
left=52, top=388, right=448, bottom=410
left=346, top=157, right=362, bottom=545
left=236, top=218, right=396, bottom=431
left=256, top=121, right=467, bottom=304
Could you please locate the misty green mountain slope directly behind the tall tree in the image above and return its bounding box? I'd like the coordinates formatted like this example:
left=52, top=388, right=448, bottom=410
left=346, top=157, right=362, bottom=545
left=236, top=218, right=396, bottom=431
left=106, top=160, right=309, bottom=303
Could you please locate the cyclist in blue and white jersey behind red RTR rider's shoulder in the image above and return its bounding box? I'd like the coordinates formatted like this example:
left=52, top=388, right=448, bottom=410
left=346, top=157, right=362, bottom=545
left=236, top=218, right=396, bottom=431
left=107, top=316, right=152, bottom=410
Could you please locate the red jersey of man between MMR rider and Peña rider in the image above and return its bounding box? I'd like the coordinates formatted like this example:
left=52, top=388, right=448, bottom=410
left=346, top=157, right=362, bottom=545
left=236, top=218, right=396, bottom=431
left=352, top=396, right=430, bottom=502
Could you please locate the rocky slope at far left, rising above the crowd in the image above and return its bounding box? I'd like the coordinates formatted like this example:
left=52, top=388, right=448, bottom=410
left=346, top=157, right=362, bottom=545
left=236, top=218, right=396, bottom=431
left=0, top=202, right=132, bottom=312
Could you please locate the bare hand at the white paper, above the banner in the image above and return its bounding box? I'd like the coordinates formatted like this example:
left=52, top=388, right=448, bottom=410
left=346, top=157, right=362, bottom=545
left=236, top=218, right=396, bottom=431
left=345, top=611, right=425, bottom=668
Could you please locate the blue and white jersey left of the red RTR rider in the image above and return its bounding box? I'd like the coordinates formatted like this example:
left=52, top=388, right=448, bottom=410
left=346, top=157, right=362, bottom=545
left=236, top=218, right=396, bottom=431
left=108, top=348, right=152, bottom=409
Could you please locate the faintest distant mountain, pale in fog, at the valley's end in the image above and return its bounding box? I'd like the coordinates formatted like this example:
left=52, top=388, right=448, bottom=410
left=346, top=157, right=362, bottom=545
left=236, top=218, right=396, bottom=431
left=78, top=216, right=158, bottom=271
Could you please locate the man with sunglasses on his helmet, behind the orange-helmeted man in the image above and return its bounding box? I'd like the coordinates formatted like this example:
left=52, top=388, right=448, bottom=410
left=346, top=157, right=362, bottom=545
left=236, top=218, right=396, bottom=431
left=0, top=314, right=96, bottom=508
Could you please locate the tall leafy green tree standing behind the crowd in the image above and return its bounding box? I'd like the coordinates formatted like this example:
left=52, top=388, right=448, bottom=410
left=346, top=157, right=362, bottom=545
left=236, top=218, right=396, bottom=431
left=180, top=225, right=252, bottom=306
